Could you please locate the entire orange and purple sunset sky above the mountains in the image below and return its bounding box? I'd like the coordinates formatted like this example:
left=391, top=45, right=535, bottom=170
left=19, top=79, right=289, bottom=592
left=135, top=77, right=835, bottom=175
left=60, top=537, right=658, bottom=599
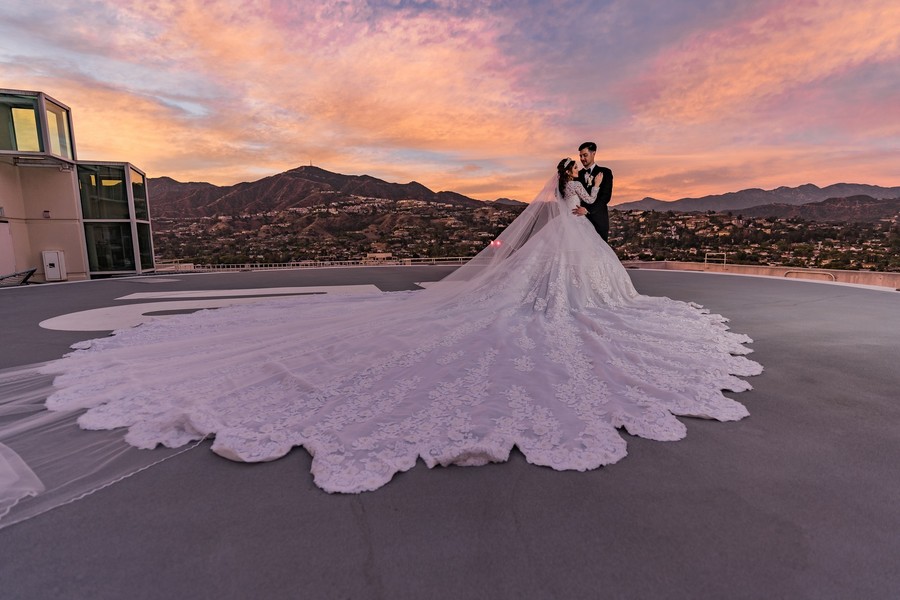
left=0, top=0, right=900, bottom=204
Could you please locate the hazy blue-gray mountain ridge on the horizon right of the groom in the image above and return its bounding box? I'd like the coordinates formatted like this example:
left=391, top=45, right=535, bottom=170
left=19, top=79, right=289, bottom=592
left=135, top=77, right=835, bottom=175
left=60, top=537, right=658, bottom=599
left=610, top=183, right=900, bottom=212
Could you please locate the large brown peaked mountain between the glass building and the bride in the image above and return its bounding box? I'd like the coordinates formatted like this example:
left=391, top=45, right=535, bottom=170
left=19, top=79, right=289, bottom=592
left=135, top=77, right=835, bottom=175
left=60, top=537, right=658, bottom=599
left=147, top=166, right=523, bottom=217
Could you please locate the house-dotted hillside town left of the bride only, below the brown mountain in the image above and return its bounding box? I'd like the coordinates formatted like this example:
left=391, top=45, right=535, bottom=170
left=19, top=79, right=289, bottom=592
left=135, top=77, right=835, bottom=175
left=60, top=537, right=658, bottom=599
left=154, top=197, right=523, bottom=264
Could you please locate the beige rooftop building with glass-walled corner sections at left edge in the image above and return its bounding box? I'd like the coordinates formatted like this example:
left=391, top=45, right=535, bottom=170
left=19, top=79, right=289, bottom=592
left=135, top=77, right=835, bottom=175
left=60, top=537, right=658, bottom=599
left=0, top=89, right=154, bottom=281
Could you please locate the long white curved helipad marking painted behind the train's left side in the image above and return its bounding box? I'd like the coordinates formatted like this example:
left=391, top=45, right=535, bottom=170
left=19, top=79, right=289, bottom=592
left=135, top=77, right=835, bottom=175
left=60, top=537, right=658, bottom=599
left=38, top=285, right=380, bottom=331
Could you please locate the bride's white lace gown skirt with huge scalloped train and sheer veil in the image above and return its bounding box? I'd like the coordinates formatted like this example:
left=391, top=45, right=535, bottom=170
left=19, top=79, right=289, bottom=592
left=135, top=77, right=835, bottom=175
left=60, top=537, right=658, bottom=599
left=0, top=176, right=762, bottom=525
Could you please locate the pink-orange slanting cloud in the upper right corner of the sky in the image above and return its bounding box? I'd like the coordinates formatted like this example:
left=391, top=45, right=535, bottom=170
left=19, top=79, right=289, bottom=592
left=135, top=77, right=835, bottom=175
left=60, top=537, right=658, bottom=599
left=637, top=0, right=900, bottom=123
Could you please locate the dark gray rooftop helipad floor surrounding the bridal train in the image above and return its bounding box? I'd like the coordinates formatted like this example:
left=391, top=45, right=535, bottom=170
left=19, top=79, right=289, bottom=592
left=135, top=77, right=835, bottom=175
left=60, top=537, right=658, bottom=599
left=0, top=267, right=900, bottom=599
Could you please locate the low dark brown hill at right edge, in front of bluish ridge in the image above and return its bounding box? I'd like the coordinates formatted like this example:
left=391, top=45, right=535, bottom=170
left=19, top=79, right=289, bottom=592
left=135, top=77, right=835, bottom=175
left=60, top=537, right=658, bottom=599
left=740, top=196, right=900, bottom=223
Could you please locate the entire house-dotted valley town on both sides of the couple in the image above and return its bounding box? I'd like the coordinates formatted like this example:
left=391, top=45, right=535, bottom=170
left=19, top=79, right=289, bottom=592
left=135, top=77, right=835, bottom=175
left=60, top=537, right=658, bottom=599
left=153, top=194, right=900, bottom=271
